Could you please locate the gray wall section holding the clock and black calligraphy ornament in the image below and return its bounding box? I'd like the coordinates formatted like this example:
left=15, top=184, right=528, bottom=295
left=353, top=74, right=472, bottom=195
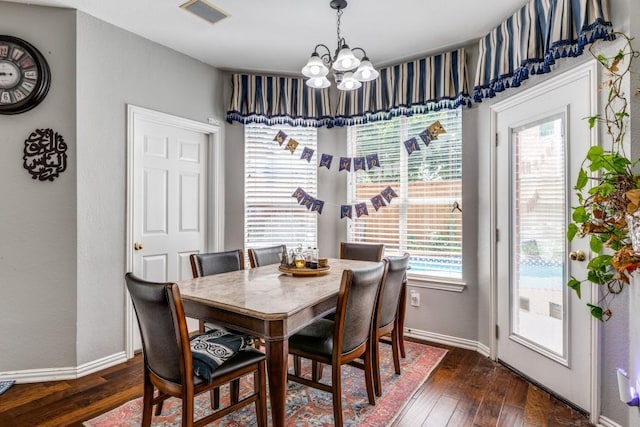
left=0, top=2, right=77, bottom=372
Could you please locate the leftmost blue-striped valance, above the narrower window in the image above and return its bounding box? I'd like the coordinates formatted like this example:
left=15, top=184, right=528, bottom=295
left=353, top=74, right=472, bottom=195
left=227, top=74, right=333, bottom=127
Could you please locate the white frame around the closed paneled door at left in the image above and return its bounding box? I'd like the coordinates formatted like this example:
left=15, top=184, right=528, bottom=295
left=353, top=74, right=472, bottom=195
left=123, top=104, right=224, bottom=359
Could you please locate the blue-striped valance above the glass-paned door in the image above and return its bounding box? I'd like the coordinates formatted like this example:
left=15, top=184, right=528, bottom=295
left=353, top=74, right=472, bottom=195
left=473, top=0, right=612, bottom=102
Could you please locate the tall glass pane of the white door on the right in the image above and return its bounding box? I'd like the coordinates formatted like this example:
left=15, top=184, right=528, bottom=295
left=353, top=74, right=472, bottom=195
left=509, top=115, right=568, bottom=364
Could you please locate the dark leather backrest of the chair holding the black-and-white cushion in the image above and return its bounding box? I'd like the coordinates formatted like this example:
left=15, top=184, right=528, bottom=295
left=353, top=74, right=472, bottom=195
left=125, top=273, right=191, bottom=385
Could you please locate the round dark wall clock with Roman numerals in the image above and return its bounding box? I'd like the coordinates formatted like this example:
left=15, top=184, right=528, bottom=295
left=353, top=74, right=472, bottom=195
left=0, top=35, right=51, bottom=114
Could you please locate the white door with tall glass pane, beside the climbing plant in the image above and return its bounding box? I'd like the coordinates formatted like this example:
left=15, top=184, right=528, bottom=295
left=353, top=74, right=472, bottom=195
left=492, top=64, right=597, bottom=412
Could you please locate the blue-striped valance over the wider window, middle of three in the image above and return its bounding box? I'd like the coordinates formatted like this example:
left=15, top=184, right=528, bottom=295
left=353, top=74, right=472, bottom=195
left=334, top=49, right=471, bottom=126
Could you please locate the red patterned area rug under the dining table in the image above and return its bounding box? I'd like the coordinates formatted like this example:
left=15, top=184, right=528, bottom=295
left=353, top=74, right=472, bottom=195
left=84, top=341, right=447, bottom=427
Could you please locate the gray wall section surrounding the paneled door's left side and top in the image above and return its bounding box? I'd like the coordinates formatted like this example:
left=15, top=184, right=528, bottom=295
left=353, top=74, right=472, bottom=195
left=77, top=13, right=224, bottom=364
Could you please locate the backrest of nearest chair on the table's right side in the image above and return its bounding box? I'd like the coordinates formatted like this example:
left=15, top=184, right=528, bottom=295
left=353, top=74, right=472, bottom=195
left=334, top=262, right=386, bottom=354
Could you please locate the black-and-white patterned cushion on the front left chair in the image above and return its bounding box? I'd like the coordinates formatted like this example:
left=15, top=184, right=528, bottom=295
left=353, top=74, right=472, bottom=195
left=190, top=329, right=253, bottom=381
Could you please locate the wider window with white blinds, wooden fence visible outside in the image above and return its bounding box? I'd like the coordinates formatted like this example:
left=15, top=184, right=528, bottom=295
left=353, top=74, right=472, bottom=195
left=348, top=108, right=462, bottom=279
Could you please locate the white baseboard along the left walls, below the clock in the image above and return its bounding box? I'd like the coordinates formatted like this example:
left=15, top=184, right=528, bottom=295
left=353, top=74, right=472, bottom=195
left=0, top=351, right=127, bottom=384
